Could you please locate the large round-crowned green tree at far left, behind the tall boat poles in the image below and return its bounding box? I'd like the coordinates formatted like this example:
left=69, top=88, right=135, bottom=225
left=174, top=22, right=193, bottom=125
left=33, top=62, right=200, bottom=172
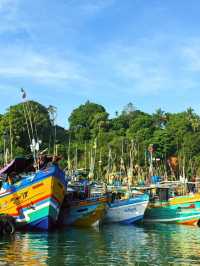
left=0, top=101, right=51, bottom=153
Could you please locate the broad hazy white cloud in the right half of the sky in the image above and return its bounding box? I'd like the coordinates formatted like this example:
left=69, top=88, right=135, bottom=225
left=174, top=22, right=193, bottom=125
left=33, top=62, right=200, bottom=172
left=86, top=34, right=200, bottom=95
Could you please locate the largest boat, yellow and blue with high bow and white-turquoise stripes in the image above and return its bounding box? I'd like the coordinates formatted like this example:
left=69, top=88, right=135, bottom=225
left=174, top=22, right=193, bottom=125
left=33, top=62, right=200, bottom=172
left=0, top=160, right=66, bottom=230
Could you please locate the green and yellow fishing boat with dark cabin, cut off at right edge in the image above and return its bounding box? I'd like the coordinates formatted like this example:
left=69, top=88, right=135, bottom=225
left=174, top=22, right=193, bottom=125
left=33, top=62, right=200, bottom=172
left=144, top=181, right=200, bottom=225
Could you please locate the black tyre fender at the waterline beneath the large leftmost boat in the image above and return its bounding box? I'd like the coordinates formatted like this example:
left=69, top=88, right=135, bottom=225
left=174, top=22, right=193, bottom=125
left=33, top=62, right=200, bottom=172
left=0, top=214, right=15, bottom=235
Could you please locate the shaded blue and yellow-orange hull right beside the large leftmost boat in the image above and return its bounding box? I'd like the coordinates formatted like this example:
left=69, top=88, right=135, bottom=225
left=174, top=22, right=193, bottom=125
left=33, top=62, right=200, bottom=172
left=59, top=197, right=107, bottom=227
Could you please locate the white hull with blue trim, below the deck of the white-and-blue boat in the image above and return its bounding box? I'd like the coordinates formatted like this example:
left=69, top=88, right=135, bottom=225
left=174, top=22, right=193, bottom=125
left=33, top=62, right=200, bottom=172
left=104, top=195, right=149, bottom=224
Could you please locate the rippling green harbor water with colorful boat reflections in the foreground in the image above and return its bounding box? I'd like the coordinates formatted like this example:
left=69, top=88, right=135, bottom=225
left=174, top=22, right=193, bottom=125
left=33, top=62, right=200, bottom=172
left=0, top=224, right=200, bottom=266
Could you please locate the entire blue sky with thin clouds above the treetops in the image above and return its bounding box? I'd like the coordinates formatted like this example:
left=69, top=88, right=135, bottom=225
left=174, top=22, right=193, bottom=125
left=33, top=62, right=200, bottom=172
left=0, top=0, right=200, bottom=127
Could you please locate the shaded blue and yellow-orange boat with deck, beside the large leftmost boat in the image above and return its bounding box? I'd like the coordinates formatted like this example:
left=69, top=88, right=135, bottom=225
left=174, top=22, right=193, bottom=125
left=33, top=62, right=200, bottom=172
left=59, top=181, right=107, bottom=227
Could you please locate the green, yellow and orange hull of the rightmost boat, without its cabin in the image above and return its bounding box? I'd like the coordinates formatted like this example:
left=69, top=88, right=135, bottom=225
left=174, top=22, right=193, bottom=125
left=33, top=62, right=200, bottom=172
left=144, top=194, right=200, bottom=225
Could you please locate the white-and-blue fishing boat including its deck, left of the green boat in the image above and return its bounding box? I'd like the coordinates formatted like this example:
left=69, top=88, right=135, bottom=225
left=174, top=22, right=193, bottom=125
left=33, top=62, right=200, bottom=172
left=103, top=189, right=149, bottom=224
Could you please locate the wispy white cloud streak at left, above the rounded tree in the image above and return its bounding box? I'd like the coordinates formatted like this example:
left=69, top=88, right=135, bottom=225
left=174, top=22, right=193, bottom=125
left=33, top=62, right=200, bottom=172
left=0, top=46, right=92, bottom=93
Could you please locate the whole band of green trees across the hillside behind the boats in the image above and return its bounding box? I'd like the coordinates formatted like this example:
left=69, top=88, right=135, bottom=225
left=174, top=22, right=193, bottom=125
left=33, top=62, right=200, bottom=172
left=0, top=101, right=200, bottom=179
